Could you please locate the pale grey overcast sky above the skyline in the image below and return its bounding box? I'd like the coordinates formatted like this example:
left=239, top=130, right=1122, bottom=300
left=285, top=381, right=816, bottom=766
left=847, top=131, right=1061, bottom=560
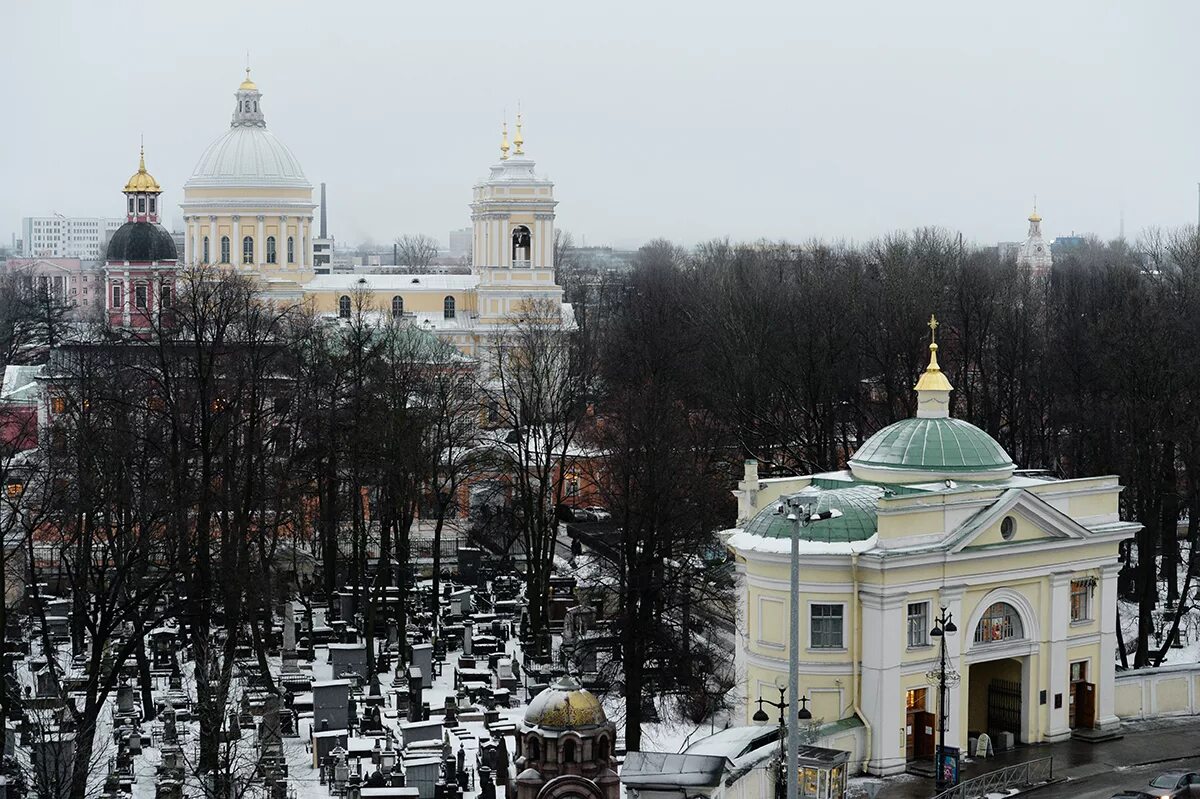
left=0, top=0, right=1200, bottom=245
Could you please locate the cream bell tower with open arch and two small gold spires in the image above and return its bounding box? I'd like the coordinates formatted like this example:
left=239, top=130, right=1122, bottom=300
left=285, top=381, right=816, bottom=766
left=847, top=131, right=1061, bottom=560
left=470, top=113, right=563, bottom=324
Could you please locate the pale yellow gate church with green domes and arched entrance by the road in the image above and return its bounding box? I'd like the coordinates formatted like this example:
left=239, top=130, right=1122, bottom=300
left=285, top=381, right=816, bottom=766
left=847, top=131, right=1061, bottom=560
left=728, top=320, right=1139, bottom=775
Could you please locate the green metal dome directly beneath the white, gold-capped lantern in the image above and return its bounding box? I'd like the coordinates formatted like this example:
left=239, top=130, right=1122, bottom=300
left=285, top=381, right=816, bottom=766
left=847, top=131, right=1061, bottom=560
left=850, top=416, right=1013, bottom=471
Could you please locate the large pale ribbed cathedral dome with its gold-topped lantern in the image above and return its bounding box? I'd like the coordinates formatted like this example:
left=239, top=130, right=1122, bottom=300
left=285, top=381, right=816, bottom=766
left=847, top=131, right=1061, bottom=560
left=184, top=70, right=312, bottom=190
